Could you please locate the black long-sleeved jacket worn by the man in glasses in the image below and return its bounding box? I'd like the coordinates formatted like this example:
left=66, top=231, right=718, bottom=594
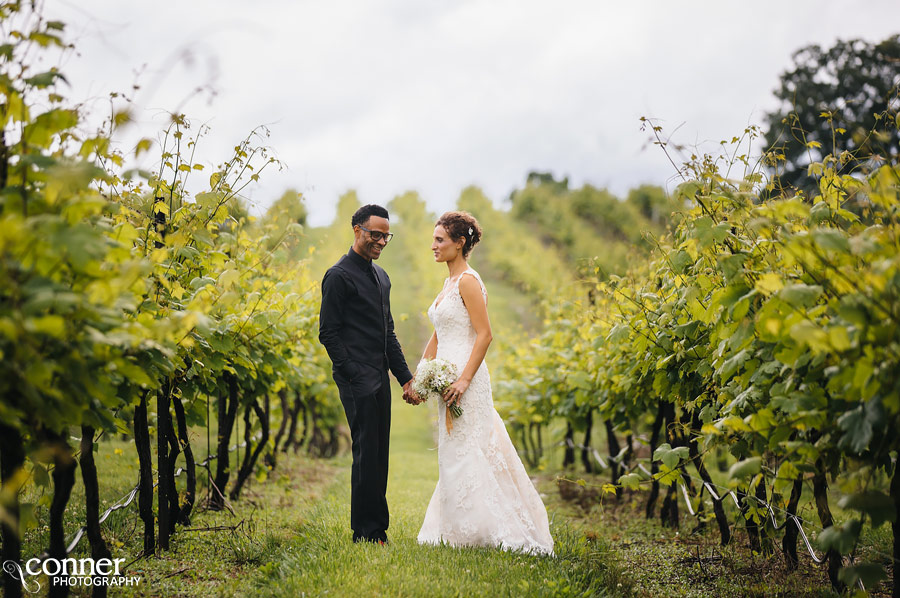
left=319, top=248, right=412, bottom=394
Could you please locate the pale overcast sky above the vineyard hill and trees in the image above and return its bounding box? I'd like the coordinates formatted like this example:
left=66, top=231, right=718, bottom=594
left=45, top=0, right=900, bottom=225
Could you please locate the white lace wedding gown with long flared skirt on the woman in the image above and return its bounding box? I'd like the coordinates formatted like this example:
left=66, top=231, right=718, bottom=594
left=418, top=268, right=553, bottom=554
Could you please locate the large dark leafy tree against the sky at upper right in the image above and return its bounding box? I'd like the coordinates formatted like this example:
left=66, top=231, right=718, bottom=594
left=765, top=35, right=900, bottom=196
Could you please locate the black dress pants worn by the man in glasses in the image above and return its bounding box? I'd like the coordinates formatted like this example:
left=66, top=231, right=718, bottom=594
left=335, top=372, right=391, bottom=542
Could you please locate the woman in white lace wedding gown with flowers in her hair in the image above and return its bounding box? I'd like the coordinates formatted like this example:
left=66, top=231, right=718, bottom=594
left=418, top=212, right=553, bottom=555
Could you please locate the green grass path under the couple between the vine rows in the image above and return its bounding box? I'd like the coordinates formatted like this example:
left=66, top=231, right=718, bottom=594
left=239, top=392, right=610, bottom=597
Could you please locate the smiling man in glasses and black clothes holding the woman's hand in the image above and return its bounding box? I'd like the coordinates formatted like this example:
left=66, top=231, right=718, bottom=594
left=319, top=204, right=418, bottom=544
